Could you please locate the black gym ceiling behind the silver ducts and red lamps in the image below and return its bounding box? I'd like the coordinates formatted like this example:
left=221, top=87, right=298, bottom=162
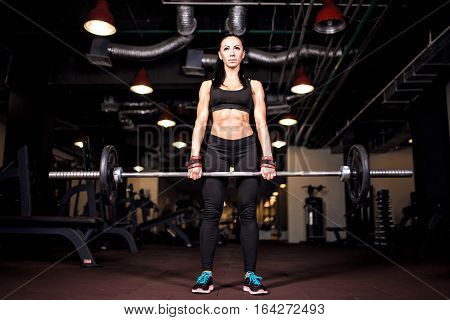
left=0, top=0, right=449, bottom=166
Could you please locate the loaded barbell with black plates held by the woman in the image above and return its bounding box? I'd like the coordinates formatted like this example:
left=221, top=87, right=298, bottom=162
left=48, top=144, right=413, bottom=203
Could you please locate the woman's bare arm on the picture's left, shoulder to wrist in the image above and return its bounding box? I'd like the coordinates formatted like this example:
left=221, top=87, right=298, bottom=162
left=191, top=80, right=212, bottom=156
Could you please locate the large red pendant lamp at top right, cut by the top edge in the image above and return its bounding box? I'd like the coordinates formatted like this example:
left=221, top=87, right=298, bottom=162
left=314, top=0, right=346, bottom=34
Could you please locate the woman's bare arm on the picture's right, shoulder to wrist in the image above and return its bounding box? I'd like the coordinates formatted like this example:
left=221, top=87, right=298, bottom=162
left=251, top=80, right=272, bottom=156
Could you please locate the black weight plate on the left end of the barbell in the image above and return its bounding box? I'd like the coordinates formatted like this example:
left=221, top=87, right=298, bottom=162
left=100, top=146, right=118, bottom=203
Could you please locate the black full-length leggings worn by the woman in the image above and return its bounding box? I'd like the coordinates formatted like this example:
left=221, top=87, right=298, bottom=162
left=200, top=134, right=261, bottom=272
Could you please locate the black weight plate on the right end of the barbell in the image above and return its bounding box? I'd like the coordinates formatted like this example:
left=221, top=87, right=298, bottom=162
left=346, top=144, right=370, bottom=203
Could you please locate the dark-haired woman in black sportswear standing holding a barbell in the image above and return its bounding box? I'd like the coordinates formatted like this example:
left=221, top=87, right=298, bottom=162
left=187, top=35, right=276, bottom=294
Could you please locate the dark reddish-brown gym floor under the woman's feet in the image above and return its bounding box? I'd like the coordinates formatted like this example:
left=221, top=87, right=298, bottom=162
left=0, top=241, right=450, bottom=300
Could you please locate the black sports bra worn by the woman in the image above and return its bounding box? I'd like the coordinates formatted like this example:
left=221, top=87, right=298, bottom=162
left=209, top=79, right=253, bottom=113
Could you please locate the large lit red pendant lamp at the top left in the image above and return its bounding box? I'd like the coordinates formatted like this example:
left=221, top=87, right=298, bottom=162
left=84, top=0, right=116, bottom=36
